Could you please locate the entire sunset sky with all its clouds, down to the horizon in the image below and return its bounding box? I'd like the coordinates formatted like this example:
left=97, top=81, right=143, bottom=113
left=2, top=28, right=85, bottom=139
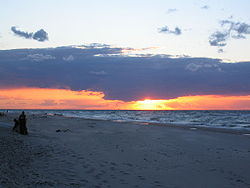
left=0, top=0, right=250, bottom=110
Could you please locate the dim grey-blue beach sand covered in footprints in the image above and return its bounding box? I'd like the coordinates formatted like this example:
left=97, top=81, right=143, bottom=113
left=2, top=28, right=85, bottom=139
left=0, top=112, right=250, bottom=188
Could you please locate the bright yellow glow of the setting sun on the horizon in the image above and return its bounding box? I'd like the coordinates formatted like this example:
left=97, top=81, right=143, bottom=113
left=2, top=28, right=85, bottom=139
left=134, top=99, right=171, bottom=110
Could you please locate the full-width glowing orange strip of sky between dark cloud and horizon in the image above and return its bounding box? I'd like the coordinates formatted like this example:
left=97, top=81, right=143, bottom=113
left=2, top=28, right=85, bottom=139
left=0, top=88, right=250, bottom=110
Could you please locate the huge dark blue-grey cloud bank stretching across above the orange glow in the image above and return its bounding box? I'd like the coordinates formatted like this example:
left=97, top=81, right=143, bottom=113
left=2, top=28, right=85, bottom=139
left=0, top=44, right=250, bottom=101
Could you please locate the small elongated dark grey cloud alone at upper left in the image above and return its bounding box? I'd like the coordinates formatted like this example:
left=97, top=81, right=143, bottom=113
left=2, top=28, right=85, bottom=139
left=11, top=26, right=49, bottom=42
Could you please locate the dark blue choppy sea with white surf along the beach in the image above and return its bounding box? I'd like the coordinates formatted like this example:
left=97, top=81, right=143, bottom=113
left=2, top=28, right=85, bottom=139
left=0, top=110, right=250, bottom=131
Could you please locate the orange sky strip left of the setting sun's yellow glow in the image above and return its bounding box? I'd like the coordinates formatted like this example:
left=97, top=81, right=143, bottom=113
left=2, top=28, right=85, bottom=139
left=0, top=88, right=131, bottom=109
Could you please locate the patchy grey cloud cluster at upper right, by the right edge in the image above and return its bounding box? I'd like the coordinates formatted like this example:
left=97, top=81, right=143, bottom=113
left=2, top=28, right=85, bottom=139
left=209, top=20, right=250, bottom=53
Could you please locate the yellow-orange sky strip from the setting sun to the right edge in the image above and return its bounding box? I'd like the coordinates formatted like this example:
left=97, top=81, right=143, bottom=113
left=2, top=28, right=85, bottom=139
left=133, top=95, right=250, bottom=110
